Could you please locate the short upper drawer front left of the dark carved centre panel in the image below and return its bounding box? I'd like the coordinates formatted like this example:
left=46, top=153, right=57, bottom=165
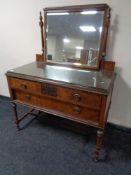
left=9, top=78, right=41, bottom=93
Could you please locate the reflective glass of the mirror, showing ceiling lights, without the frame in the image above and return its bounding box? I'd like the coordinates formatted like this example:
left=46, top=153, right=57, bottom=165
left=46, top=10, right=104, bottom=67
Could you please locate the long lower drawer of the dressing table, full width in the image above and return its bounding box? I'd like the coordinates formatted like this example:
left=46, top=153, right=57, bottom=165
left=15, top=91, right=100, bottom=123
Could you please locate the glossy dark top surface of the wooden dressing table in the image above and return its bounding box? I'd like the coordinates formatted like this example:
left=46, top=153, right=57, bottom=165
left=6, top=62, right=115, bottom=95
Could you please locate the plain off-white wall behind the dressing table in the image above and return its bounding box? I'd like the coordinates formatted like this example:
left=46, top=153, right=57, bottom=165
left=0, top=0, right=131, bottom=127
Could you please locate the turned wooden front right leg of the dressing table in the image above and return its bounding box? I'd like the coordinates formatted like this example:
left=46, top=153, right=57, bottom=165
left=95, top=130, right=103, bottom=161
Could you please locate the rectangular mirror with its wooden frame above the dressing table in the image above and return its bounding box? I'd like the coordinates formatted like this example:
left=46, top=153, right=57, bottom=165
left=44, top=4, right=109, bottom=69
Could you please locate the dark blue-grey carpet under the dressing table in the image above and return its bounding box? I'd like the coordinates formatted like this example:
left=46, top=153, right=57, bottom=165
left=0, top=98, right=131, bottom=175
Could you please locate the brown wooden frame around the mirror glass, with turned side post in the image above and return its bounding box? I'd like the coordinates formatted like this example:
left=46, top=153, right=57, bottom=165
left=39, top=4, right=110, bottom=70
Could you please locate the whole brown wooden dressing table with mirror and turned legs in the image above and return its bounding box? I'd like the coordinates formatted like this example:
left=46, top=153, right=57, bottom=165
left=6, top=4, right=115, bottom=161
